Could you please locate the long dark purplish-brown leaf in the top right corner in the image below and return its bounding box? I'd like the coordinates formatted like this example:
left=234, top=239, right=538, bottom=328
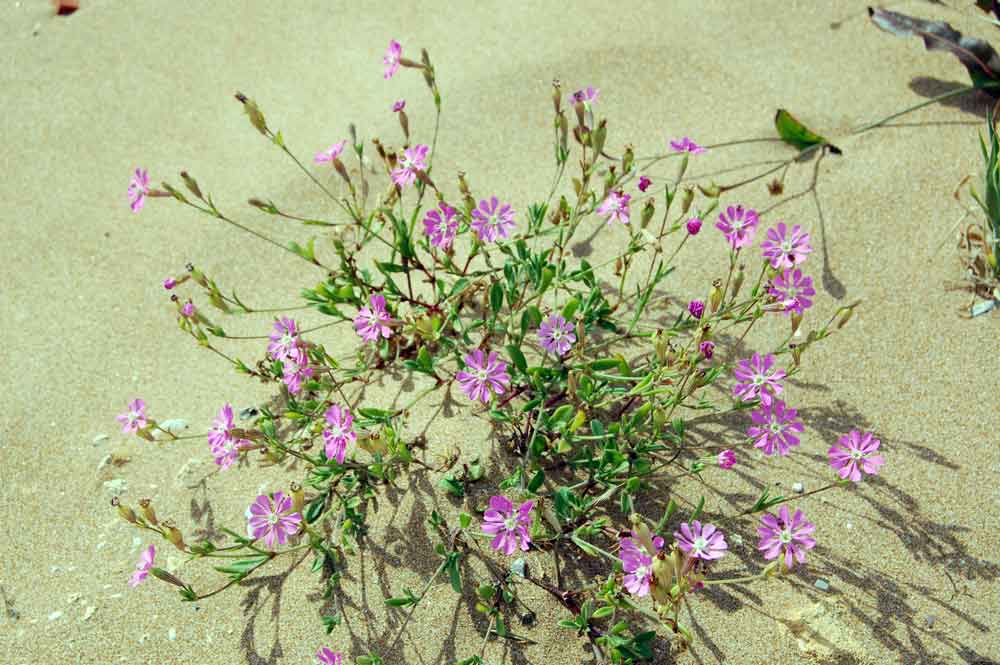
left=868, top=7, right=1000, bottom=97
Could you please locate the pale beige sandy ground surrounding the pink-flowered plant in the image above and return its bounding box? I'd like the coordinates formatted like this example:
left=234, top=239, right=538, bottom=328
left=0, top=0, right=1000, bottom=665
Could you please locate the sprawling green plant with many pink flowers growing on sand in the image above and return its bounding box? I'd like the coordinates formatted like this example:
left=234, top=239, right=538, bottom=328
left=113, top=41, right=883, bottom=665
